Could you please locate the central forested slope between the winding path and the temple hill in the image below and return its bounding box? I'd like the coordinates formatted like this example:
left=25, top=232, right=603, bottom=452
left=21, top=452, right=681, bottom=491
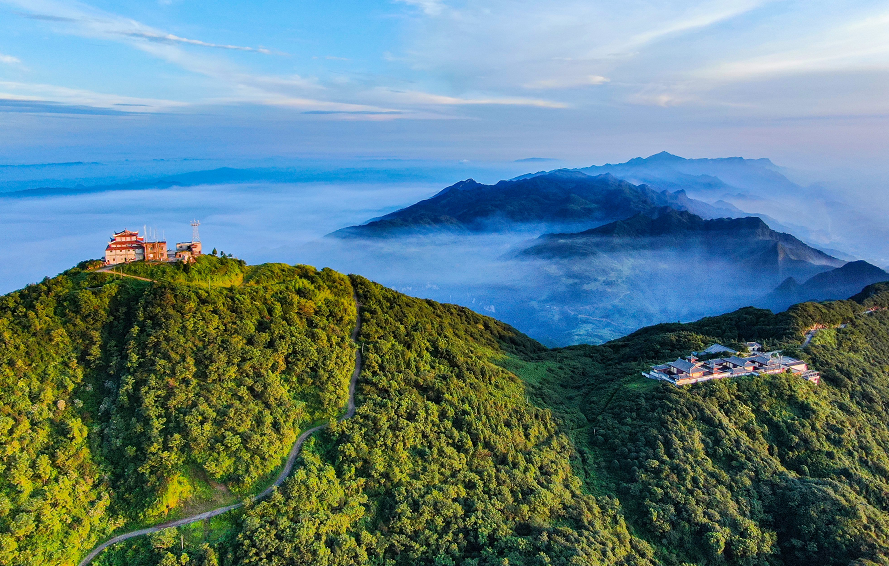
left=102, top=277, right=652, bottom=565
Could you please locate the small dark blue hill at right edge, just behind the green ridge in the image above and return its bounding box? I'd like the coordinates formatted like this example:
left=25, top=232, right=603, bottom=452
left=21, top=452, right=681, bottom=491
left=764, top=261, right=889, bottom=310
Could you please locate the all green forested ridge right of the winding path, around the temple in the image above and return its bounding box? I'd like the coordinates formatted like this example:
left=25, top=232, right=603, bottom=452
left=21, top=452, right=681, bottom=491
left=103, top=278, right=889, bottom=566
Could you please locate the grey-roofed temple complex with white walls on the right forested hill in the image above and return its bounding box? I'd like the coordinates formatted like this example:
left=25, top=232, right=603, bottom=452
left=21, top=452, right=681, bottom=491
left=642, top=343, right=821, bottom=385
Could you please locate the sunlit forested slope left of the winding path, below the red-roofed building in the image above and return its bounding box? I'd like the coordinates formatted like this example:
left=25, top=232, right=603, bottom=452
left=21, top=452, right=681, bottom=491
left=0, top=256, right=355, bottom=565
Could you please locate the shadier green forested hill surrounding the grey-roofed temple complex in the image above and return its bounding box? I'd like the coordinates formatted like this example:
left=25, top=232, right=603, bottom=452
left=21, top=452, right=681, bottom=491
left=503, top=285, right=889, bottom=565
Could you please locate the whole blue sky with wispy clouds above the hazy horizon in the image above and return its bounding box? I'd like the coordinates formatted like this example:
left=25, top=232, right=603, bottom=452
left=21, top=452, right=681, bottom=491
left=0, top=0, right=889, bottom=168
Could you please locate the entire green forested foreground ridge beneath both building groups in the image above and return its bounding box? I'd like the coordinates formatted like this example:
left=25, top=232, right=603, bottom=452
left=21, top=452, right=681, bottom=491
left=0, top=258, right=889, bottom=566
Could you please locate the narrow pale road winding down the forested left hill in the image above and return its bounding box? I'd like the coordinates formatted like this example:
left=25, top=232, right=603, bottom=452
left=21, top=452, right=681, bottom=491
left=78, top=292, right=362, bottom=566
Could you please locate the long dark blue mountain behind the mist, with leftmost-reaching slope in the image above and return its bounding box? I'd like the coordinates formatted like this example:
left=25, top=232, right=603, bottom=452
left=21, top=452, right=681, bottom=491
left=333, top=170, right=736, bottom=238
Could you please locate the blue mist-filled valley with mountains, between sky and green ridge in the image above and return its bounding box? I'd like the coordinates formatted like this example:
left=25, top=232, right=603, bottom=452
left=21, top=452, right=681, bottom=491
left=0, top=153, right=886, bottom=345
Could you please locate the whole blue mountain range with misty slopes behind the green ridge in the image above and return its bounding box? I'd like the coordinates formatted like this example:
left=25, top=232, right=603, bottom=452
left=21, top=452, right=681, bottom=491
left=320, top=153, right=889, bottom=345
